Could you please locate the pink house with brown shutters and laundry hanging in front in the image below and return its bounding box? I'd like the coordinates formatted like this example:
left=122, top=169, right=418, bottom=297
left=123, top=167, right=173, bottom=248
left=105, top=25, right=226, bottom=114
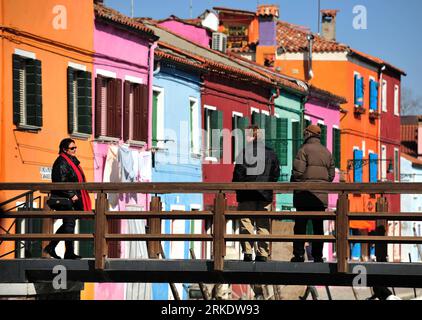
left=91, top=4, right=157, bottom=300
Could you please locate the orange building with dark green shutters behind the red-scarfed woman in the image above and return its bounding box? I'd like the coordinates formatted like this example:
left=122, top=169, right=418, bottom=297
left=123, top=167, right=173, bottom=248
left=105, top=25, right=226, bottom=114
left=0, top=0, right=94, bottom=258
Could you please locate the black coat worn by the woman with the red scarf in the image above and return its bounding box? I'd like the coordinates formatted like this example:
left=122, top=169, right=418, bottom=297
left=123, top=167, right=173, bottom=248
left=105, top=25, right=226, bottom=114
left=51, top=155, right=82, bottom=200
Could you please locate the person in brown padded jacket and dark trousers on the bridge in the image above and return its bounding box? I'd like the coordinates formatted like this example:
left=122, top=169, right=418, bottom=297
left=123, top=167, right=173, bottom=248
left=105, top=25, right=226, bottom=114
left=290, top=125, right=335, bottom=262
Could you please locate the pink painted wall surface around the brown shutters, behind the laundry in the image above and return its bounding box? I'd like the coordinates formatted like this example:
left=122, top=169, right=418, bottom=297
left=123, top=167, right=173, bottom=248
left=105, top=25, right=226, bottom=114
left=93, top=20, right=152, bottom=300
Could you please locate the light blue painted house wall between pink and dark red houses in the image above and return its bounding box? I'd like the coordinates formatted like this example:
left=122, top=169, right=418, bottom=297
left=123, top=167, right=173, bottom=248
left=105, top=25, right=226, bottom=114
left=152, top=62, right=203, bottom=299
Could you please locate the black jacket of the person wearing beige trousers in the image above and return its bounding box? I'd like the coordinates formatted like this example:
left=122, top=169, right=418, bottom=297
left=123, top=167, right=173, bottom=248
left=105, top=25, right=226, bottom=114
left=232, top=142, right=280, bottom=202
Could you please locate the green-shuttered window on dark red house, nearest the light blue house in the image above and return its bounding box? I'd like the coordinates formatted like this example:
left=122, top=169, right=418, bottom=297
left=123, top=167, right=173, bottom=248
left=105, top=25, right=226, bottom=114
left=204, top=106, right=223, bottom=160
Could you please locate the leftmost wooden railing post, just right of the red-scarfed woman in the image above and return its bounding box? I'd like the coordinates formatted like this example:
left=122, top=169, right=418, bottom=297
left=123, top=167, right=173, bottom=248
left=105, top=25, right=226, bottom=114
left=94, top=192, right=108, bottom=270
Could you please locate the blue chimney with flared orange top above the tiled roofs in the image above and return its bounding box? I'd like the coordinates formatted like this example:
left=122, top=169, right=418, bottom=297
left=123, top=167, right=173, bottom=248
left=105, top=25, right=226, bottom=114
left=256, top=4, right=279, bottom=46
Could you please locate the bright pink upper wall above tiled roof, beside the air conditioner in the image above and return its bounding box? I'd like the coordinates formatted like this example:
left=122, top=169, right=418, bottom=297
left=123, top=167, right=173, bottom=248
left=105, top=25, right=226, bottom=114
left=159, top=20, right=211, bottom=48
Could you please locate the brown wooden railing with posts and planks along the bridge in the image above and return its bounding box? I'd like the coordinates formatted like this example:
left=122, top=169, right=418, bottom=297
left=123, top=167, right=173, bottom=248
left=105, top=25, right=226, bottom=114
left=0, top=183, right=422, bottom=273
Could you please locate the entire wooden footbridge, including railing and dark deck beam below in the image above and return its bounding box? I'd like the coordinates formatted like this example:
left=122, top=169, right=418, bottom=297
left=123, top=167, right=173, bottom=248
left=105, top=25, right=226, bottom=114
left=0, top=183, right=422, bottom=287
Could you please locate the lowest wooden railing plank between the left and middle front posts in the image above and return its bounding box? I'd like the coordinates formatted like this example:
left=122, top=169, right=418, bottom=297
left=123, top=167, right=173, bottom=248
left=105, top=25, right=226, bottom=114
left=105, top=233, right=213, bottom=243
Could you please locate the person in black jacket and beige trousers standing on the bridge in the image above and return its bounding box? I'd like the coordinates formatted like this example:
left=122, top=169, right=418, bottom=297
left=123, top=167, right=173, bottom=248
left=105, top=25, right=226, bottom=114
left=233, top=126, right=280, bottom=261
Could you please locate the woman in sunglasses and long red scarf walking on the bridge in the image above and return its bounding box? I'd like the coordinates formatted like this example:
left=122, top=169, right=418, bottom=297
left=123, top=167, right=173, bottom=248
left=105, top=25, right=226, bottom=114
left=44, top=138, right=92, bottom=259
